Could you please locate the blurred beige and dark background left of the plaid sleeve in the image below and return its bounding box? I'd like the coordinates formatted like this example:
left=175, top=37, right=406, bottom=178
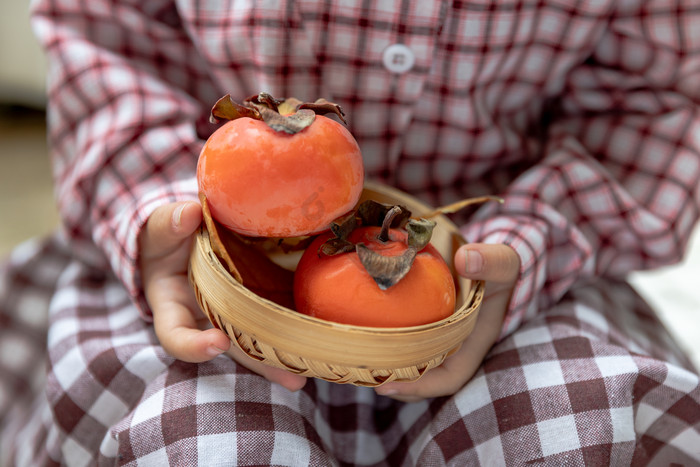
left=0, top=0, right=58, bottom=257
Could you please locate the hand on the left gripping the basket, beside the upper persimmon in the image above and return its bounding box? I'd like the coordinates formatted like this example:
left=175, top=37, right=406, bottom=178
left=139, top=201, right=306, bottom=391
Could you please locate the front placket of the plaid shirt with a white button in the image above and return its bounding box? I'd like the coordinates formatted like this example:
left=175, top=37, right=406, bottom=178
left=297, top=0, right=447, bottom=182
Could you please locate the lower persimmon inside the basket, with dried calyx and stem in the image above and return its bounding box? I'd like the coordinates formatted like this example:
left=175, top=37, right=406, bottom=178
left=294, top=202, right=456, bottom=327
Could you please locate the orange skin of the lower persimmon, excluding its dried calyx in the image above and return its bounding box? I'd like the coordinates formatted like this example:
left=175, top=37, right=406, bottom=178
left=294, top=227, right=456, bottom=327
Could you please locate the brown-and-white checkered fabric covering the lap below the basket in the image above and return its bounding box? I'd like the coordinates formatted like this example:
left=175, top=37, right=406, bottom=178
left=0, top=239, right=700, bottom=466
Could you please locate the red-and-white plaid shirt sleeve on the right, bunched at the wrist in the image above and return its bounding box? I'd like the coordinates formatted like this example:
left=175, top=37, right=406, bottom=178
left=463, top=1, right=700, bottom=336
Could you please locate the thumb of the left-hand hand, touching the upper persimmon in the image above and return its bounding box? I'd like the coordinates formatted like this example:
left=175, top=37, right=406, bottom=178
left=140, top=201, right=202, bottom=259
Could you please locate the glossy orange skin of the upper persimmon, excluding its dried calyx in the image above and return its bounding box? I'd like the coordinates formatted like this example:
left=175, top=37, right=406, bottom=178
left=197, top=115, right=364, bottom=237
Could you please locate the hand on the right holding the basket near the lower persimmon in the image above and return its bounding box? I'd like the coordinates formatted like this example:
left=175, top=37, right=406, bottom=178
left=376, top=243, right=520, bottom=402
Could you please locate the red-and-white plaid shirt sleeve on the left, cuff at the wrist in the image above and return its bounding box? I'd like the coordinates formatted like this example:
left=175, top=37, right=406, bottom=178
left=32, top=0, right=215, bottom=317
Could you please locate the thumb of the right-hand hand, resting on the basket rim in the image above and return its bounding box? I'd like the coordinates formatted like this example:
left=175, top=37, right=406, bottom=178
left=455, top=243, right=520, bottom=283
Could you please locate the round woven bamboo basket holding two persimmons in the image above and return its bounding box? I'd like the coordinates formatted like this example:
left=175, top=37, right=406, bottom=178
left=189, top=183, right=484, bottom=386
